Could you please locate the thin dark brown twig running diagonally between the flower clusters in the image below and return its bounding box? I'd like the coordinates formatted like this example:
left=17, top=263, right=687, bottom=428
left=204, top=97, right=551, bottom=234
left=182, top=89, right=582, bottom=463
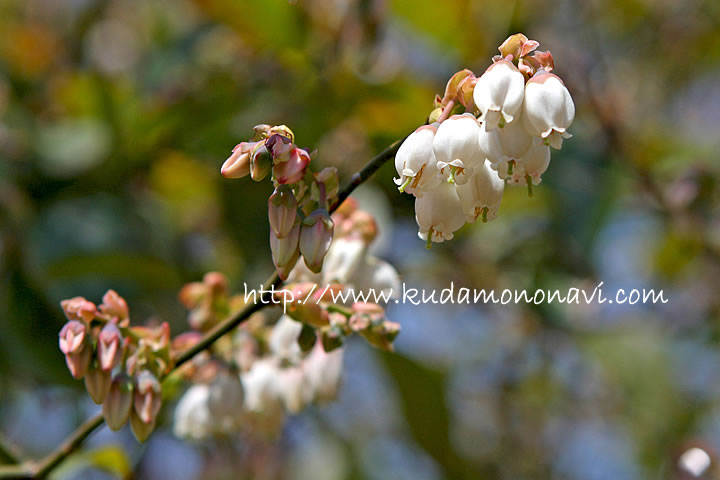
left=0, top=132, right=407, bottom=478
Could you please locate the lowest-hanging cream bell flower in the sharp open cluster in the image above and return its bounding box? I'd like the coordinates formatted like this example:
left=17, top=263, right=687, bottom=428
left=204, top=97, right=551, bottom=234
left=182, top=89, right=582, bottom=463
left=415, top=182, right=465, bottom=245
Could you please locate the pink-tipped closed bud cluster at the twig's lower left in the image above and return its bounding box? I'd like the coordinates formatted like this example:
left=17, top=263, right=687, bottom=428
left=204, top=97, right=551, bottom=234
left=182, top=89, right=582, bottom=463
left=59, top=290, right=172, bottom=442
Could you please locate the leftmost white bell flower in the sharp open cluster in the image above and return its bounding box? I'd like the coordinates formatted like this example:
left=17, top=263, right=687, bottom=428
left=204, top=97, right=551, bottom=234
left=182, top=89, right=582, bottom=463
left=395, top=125, right=442, bottom=197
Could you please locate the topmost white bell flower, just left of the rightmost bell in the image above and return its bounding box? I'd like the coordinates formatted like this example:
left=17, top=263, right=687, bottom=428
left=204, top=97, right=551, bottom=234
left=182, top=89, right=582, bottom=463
left=473, top=59, right=525, bottom=131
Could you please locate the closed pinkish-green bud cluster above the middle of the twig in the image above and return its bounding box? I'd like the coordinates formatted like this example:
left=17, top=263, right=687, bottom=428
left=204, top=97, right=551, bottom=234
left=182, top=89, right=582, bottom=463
left=220, top=125, right=339, bottom=280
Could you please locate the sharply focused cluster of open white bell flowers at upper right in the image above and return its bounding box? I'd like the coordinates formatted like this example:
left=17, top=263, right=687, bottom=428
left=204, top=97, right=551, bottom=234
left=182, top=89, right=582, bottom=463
left=395, top=33, right=575, bottom=247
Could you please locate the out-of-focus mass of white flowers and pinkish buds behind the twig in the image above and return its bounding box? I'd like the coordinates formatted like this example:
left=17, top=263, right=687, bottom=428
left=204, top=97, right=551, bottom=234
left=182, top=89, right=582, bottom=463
left=173, top=202, right=400, bottom=439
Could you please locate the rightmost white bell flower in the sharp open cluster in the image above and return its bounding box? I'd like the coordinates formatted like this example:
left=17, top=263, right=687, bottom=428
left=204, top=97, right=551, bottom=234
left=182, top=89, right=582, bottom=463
left=522, top=72, right=575, bottom=149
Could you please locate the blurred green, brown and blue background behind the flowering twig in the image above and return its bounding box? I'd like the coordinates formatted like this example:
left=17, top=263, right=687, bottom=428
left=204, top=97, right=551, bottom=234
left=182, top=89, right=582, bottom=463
left=0, top=0, right=720, bottom=480
